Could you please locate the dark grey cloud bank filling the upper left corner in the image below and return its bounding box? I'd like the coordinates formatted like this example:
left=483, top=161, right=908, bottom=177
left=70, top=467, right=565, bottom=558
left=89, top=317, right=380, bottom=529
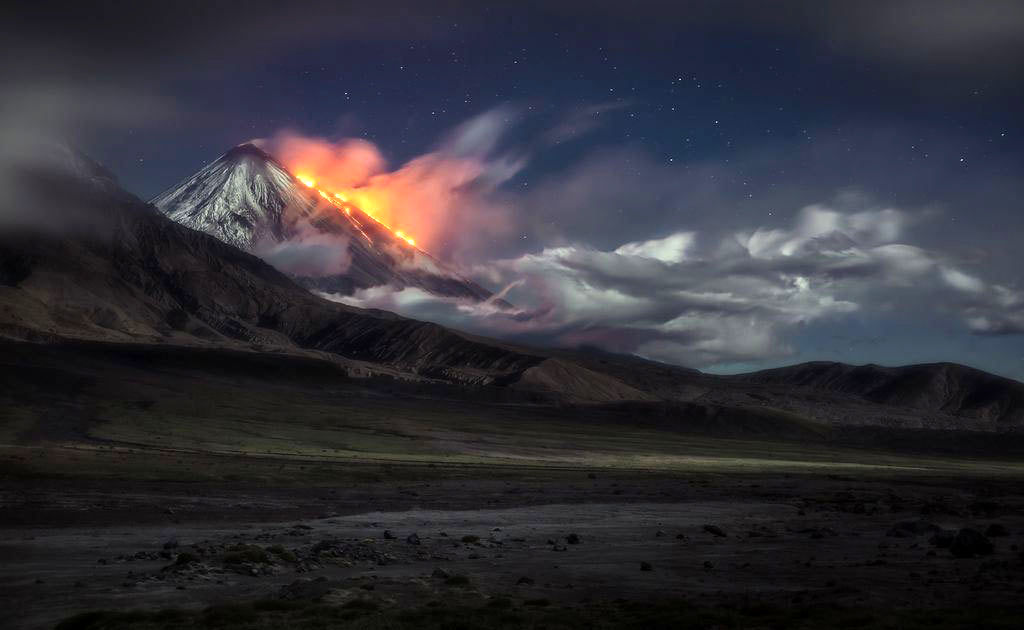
left=0, top=0, right=471, bottom=222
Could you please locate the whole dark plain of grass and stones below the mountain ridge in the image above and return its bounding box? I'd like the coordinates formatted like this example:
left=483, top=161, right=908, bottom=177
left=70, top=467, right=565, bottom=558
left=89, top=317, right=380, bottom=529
left=6, top=344, right=1024, bottom=629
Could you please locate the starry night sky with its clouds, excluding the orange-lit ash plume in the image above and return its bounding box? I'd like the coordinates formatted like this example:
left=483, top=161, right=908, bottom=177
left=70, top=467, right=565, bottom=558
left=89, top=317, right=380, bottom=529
left=6, top=0, right=1024, bottom=379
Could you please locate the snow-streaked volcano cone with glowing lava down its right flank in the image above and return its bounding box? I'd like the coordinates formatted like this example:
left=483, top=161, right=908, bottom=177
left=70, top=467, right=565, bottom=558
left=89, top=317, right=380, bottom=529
left=151, top=142, right=492, bottom=301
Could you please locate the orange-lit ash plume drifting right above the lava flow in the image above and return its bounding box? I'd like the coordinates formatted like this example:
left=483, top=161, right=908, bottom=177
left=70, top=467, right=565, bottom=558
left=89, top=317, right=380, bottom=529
left=260, top=107, right=527, bottom=261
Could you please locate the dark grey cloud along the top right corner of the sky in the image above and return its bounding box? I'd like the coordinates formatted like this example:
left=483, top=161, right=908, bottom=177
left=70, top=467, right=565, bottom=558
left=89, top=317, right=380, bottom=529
left=538, top=0, right=1024, bottom=77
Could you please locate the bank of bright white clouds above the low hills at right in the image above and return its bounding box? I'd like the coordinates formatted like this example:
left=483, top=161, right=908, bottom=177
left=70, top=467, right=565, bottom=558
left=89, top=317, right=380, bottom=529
left=321, top=193, right=1024, bottom=368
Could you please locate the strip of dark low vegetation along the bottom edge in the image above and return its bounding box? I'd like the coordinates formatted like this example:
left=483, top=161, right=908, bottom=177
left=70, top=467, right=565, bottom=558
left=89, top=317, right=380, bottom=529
left=56, top=598, right=1024, bottom=630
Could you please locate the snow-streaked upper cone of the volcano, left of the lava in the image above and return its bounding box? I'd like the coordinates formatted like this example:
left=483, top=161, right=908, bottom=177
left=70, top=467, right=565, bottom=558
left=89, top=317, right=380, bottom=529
left=153, top=142, right=315, bottom=250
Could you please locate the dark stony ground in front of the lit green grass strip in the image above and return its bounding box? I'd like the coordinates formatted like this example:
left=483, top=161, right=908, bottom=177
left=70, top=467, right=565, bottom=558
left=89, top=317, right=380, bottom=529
left=6, top=455, right=1024, bottom=628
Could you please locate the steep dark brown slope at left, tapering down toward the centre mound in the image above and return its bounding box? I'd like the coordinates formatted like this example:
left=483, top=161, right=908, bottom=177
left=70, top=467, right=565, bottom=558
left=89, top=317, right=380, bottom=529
left=0, top=157, right=542, bottom=382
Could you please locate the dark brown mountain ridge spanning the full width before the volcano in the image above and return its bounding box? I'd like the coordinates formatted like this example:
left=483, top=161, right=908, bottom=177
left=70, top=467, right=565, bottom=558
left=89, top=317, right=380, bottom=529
left=0, top=149, right=1024, bottom=431
